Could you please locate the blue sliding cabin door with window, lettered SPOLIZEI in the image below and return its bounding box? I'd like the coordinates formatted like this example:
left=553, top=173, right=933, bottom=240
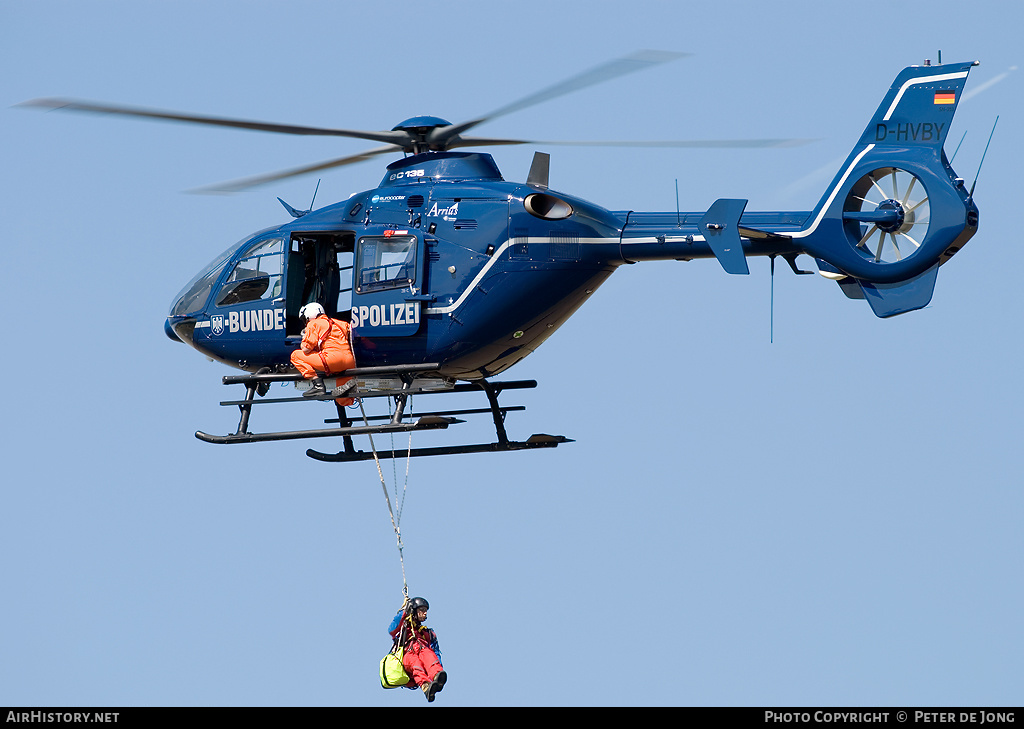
left=351, top=226, right=429, bottom=337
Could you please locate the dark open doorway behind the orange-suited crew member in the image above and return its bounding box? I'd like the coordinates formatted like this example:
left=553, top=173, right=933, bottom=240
left=285, top=230, right=355, bottom=337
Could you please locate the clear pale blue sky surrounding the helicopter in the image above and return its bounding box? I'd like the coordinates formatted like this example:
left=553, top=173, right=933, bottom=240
left=0, top=0, right=1024, bottom=706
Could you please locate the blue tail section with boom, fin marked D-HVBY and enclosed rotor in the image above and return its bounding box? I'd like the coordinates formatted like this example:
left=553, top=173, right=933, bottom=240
left=620, top=62, right=978, bottom=316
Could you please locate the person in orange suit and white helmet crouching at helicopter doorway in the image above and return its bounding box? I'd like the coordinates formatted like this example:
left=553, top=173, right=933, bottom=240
left=291, top=301, right=355, bottom=405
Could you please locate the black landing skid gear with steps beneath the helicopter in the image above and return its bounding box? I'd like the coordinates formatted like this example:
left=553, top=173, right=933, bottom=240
left=196, top=365, right=572, bottom=463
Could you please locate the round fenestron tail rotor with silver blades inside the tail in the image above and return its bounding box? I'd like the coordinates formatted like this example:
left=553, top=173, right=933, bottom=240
left=843, top=167, right=931, bottom=263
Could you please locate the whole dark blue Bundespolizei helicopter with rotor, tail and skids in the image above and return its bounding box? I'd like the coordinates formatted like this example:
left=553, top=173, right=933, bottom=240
left=27, top=51, right=978, bottom=462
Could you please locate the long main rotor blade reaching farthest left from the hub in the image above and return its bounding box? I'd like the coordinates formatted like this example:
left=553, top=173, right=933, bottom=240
left=16, top=98, right=409, bottom=145
